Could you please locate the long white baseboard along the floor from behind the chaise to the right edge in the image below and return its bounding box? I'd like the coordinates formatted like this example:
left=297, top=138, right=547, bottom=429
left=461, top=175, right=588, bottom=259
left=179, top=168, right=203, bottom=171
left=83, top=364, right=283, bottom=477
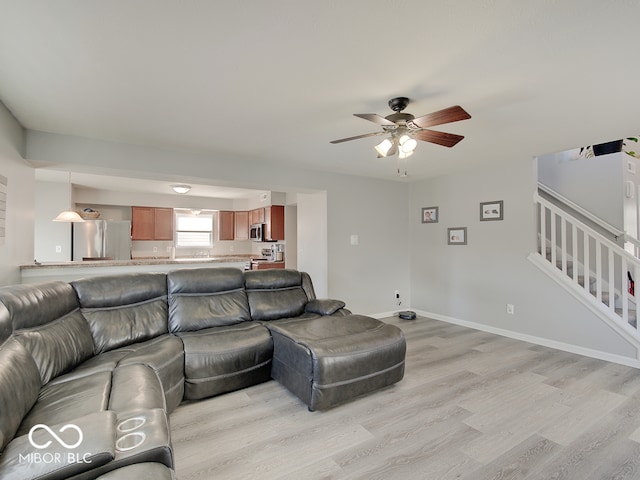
left=371, top=310, right=640, bottom=368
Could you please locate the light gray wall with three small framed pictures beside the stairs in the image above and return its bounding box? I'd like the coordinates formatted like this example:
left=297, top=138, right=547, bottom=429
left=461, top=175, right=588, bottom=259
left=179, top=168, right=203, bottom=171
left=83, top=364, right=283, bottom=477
left=409, top=159, right=635, bottom=359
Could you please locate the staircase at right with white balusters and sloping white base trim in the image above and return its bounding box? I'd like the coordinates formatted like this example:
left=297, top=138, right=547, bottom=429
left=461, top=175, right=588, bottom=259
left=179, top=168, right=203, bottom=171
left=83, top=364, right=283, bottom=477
left=529, top=192, right=640, bottom=352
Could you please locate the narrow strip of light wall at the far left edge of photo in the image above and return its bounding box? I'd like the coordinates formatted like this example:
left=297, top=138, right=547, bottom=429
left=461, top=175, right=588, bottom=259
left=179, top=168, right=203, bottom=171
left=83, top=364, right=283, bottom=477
left=0, top=103, right=35, bottom=285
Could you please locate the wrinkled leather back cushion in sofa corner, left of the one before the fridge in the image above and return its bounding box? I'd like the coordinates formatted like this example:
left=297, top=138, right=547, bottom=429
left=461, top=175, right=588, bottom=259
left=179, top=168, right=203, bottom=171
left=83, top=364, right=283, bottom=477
left=0, top=282, right=94, bottom=385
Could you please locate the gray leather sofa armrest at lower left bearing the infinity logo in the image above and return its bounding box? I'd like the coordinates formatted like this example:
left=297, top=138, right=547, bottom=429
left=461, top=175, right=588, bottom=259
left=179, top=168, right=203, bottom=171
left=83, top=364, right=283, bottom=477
left=0, top=411, right=116, bottom=480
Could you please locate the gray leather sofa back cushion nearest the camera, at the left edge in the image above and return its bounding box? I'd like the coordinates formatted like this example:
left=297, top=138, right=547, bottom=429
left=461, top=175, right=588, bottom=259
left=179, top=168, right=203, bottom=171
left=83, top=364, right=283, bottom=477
left=0, top=338, right=42, bottom=452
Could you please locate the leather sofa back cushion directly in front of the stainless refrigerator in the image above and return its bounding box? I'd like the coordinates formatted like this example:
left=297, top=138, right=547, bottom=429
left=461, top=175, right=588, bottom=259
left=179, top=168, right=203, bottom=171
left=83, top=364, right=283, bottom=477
left=71, top=273, right=168, bottom=353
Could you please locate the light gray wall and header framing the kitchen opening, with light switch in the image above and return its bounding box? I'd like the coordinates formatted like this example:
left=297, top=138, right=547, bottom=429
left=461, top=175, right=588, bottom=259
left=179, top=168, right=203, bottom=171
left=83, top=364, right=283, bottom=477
left=27, top=131, right=409, bottom=314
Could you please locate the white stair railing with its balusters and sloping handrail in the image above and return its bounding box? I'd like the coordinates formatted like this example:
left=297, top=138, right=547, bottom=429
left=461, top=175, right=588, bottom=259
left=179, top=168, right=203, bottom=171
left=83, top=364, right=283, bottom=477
left=534, top=193, right=640, bottom=334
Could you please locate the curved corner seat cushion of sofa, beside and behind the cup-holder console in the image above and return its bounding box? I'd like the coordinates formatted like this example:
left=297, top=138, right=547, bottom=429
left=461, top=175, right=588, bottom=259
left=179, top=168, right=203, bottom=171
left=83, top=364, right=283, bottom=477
left=116, top=335, right=184, bottom=412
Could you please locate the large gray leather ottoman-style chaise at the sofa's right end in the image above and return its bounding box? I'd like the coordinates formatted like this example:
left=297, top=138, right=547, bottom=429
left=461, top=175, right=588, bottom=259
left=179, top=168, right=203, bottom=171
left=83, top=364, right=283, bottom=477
left=265, top=315, right=406, bottom=411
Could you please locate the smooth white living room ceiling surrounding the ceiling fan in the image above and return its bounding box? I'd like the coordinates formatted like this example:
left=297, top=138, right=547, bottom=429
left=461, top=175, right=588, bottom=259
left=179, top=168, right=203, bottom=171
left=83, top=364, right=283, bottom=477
left=0, top=0, right=640, bottom=188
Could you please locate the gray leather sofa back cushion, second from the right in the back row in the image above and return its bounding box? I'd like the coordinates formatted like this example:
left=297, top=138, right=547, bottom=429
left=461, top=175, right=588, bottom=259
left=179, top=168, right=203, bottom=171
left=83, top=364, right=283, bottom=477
left=167, top=267, right=251, bottom=332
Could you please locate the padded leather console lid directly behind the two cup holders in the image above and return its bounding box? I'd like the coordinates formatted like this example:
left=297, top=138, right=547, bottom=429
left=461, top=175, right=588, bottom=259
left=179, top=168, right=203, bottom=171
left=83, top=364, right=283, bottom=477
left=109, top=364, right=166, bottom=412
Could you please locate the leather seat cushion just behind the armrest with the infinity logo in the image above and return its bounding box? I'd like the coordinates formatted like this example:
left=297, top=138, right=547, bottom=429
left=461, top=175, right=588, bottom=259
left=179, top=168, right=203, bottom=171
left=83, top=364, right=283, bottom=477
left=17, top=372, right=111, bottom=435
